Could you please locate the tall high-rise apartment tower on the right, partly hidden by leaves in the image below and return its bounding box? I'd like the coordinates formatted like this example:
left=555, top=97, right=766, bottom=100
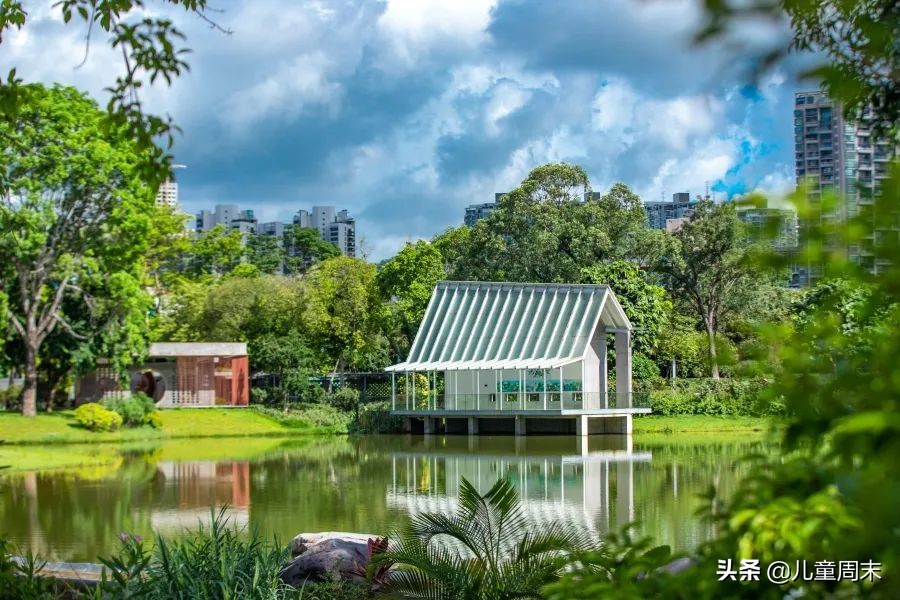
left=794, top=91, right=895, bottom=285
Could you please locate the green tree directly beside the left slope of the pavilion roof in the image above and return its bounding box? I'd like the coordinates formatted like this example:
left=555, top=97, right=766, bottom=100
left=376, top=241, right=445, bottom=356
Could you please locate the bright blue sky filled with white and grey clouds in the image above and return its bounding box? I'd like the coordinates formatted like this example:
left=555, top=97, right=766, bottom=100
left=0, top=0, right=798, bottom=260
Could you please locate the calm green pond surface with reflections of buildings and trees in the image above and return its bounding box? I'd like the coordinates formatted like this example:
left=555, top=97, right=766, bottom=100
left=0, top=434, right=767, bottom=561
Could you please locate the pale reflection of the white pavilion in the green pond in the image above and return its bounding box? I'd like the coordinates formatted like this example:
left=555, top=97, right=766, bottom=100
left=387, top=436, right=652, bottom=535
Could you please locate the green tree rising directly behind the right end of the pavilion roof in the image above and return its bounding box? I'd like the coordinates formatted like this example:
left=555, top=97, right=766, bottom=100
left=581, top=260, right=672, bottom=355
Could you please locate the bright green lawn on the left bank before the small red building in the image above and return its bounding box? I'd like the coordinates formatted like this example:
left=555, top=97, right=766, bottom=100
left=0, top=408, right=335, bottom=445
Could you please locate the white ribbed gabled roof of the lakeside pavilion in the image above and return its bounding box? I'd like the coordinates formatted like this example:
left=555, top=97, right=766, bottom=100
left=386, top=281, right=631, bottom=371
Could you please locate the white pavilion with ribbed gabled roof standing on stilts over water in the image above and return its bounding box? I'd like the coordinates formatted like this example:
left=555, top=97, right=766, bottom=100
left=386, top=281, right=650, bottom=435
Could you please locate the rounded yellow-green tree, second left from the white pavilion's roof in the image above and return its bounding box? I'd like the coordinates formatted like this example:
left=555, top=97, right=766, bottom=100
left=303, top=256, right=387, bottom=371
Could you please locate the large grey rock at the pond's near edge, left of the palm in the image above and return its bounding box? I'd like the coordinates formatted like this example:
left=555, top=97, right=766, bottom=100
left=281, top=531, right=379, bottom=588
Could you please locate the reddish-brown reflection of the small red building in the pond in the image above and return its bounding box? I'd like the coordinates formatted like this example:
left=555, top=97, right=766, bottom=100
left=150, top=461, right=250, bottom=531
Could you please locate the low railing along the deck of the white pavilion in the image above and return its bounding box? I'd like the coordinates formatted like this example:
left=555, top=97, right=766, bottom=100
left=392, top=391, right=649, bottom=412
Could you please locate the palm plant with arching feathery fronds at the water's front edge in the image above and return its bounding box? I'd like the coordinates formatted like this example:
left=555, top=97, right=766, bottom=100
left=372, top=478, right=592, bottom=600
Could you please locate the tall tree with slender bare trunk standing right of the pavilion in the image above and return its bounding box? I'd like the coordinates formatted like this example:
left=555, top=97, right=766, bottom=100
left=656, top=201, right=760, bottom=379
